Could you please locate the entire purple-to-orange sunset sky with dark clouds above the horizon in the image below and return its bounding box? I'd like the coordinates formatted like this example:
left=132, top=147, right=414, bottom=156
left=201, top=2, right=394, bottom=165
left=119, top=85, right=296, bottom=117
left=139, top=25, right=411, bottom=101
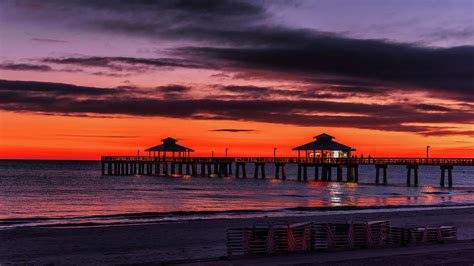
left=0, top=0, right=474, bottom=159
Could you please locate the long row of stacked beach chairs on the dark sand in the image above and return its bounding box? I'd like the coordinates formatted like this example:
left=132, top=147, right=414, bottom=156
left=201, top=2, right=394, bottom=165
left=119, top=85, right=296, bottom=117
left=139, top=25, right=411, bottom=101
left=227, top=218, right=457, bottom=257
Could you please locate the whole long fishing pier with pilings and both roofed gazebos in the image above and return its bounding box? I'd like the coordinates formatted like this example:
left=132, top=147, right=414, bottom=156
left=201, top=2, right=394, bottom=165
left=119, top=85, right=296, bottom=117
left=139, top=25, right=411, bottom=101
left=102, top=134, right=474, bottom=187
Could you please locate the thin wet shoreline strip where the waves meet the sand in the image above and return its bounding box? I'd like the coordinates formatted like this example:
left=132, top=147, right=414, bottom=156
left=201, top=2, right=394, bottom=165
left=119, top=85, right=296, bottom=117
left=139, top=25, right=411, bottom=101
left=0, top=203, right=474, bottom=230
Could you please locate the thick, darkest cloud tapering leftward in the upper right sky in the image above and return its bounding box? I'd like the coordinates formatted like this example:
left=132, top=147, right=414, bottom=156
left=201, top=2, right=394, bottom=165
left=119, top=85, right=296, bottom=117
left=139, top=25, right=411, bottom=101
left=182, top=41, right=474, bottom=99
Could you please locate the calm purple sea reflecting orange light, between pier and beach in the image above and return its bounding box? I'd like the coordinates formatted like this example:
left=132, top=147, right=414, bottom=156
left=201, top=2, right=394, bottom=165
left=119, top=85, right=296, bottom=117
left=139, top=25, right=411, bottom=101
left=0, top=161, right=474, bottom=229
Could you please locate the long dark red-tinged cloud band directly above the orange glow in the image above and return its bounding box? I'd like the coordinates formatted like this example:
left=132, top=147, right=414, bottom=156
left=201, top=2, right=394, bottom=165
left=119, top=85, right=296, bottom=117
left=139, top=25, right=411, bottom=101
left=0, top=81, right=474, bottom=134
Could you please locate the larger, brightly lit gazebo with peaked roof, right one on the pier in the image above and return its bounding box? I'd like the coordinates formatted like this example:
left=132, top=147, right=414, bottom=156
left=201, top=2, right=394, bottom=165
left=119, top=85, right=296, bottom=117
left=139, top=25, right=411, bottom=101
left=293, top=133, right=355, bottom=161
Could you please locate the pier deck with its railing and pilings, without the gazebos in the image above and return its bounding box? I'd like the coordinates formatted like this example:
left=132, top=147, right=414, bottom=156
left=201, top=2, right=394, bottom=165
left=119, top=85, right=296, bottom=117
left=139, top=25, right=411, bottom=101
left=102, top=156, right=474, bottom=187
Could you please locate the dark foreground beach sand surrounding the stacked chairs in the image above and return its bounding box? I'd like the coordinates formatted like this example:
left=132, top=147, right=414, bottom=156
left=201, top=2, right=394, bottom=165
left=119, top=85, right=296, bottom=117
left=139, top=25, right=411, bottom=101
left=0, top=207, right=474, bottom=265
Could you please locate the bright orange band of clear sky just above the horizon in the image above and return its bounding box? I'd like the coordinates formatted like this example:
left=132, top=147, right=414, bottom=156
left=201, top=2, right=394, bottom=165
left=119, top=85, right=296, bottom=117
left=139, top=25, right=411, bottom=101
left=0, top=112, right=474, bottom=160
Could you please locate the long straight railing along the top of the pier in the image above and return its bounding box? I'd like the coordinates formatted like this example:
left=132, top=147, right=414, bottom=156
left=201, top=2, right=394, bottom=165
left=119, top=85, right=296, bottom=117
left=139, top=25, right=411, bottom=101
left=101, top=156, right=474, bottom=166
